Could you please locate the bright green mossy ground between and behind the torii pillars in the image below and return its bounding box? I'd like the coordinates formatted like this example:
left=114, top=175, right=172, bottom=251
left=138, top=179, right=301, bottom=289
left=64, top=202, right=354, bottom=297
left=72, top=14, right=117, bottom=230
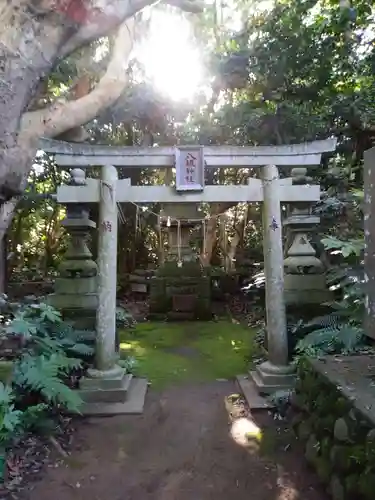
left=120, top=320, right=256, bottom=389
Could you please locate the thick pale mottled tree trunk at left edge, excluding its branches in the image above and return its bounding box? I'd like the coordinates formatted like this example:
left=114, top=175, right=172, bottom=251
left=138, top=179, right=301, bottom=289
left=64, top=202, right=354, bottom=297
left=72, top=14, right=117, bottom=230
left=0, top=8, right=77, bottom=200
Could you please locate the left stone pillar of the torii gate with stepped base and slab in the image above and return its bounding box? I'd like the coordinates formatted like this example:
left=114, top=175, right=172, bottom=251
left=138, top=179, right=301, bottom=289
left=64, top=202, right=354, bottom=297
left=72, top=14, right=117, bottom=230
left=80, top=165, right=147, bottom=415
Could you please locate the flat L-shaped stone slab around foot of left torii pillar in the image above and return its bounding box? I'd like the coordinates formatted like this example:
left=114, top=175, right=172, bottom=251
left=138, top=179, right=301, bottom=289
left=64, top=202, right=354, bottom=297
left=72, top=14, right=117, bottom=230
left=81, top=378, right=148, bottom=417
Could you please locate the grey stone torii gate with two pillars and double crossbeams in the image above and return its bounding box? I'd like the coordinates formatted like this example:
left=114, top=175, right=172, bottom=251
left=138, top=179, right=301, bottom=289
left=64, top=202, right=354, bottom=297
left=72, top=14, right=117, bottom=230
left=40, top=135, right=336, bottom=414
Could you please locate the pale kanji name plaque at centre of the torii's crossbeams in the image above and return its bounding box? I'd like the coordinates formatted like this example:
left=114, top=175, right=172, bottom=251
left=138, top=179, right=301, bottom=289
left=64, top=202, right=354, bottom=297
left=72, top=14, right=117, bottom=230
left=175, top=147, right=204, bottom=191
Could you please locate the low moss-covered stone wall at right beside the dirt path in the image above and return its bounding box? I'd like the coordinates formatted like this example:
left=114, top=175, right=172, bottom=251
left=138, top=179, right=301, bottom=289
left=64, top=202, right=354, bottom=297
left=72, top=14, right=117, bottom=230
left=293, top=360, right=375, bottom=500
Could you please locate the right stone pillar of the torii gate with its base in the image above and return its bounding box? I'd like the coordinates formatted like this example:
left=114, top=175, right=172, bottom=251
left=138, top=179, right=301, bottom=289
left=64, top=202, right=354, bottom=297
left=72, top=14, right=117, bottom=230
left=250, top=165, right=295, bottom=394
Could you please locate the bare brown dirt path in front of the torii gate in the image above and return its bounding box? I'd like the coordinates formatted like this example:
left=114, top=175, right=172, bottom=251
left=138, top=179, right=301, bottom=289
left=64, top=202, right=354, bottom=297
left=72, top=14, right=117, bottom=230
left=28, top=382, right=328, bottom=500
